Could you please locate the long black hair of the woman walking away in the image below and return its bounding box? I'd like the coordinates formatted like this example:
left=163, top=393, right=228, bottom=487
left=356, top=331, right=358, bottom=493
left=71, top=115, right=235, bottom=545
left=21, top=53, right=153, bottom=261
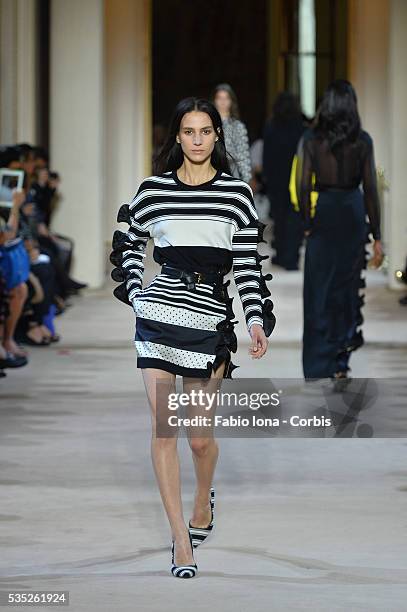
left=314, top=79, right=361, bottom=153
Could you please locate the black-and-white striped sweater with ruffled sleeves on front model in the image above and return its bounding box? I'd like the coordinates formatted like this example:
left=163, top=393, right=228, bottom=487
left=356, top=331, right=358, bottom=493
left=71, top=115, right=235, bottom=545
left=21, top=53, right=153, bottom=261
left=112, top=170, right=271, bottom=329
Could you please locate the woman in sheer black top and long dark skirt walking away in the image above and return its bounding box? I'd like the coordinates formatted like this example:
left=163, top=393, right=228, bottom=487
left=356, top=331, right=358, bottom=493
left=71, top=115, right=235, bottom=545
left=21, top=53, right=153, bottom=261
left=297, top=80, right=383, bottom=379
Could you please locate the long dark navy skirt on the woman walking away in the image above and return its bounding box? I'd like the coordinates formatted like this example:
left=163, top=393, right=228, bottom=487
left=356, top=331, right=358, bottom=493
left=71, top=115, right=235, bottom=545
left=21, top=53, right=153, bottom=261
left=302, top=189, right=367, bottom=378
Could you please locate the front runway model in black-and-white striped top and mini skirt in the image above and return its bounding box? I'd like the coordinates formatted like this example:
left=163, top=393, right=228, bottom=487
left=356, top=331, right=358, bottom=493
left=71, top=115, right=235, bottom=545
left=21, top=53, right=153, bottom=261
left=111, top=98, right=275, bottom=578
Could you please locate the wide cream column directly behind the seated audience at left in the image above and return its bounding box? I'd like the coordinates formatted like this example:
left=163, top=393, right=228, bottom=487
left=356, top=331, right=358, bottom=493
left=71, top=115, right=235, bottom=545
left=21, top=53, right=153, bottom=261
left=50, top=0, right=106, bottom=287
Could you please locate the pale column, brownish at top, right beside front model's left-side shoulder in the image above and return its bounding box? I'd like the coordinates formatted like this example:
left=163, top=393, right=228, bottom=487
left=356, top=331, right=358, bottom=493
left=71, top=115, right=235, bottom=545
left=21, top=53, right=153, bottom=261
left=105, top=0, right=152, bottom=245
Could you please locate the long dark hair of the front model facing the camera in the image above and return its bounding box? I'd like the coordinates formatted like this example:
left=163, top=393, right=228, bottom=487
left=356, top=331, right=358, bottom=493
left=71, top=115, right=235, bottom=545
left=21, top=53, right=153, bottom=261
left=153, top=97, right=230, bottom=174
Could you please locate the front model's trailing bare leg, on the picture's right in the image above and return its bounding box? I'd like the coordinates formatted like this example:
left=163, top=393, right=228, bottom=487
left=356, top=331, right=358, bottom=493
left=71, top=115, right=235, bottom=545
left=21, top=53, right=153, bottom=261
left=183, top=363, right=225, bottom=527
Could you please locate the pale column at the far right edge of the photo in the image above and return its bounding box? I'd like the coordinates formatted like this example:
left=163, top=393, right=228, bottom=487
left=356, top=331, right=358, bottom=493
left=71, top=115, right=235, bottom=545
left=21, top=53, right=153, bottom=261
left=385, top=0, right=407, bottom=289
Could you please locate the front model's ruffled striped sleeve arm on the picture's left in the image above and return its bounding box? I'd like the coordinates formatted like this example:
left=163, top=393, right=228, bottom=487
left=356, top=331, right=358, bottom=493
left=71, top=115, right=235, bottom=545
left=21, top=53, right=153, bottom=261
left=110, top=185, right=151, bottom=304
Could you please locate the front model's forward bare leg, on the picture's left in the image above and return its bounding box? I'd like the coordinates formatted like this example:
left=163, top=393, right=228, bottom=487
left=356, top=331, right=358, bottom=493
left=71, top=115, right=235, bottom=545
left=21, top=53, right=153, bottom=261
left=142, top=368, right=194, bottom=565
